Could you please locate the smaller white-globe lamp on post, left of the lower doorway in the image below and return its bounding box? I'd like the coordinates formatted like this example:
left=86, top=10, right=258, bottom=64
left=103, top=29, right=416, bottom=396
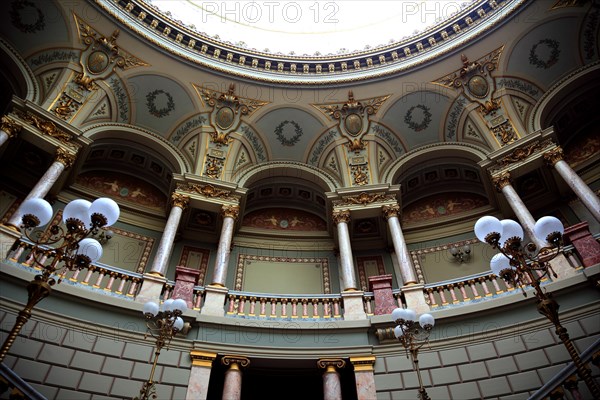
left=133, top=299, right=187, bottom=400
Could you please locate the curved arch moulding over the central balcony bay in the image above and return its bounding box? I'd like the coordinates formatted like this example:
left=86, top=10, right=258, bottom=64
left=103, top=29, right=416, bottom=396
left=238, top=161, right=341, bottom=192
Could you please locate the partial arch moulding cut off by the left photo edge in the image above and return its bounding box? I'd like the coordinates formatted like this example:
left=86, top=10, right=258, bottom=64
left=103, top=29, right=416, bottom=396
left=0, top=38, right=41, bottom=104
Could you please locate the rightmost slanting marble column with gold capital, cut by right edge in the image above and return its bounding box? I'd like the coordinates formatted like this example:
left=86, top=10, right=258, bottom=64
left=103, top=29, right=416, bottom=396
left=544, top=147, right=600, bottom=221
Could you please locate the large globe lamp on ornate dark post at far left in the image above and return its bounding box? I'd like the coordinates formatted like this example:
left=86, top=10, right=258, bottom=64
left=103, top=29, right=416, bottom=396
left=0, top=197, right=119, bottom=362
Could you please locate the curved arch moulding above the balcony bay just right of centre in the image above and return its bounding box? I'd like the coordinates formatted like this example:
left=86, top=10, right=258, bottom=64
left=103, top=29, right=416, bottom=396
left=382, top=142, right=487, bottom=185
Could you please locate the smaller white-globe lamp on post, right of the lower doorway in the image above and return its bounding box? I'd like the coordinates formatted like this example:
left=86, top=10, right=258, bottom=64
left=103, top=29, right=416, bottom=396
left=392, top=308, right=435, bottom=400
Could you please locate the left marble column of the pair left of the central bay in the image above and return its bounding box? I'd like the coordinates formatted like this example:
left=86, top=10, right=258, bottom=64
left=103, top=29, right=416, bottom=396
left=150, top=193, right=190, bottom=276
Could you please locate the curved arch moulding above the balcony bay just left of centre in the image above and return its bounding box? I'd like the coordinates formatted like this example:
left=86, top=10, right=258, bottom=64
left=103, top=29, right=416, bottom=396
left=84, top=123, right=191, bottom=174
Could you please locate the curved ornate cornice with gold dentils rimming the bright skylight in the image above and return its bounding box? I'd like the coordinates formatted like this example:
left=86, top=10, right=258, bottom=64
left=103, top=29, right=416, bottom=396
left=94, top=0, right=529, bottom=86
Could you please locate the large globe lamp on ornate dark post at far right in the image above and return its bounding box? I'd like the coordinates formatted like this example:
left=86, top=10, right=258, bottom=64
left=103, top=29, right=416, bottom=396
left=474, top=216, right=600, bottom=399
